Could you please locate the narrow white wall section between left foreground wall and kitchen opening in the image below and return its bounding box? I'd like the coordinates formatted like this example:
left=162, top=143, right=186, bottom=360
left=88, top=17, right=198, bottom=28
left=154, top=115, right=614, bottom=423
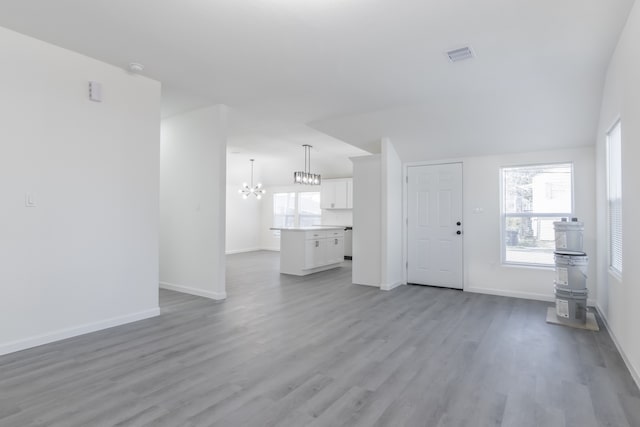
left=160, top=106, right=227, bottom=299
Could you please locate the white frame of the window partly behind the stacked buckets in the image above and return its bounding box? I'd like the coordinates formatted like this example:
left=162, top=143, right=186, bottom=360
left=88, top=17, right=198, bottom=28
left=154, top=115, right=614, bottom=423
left=498, top=161, right=575, bottom=269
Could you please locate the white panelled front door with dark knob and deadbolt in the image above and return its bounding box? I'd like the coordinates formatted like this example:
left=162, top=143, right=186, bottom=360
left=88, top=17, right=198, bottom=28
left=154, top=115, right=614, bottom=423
left=407, top=163, right=463, bottom=289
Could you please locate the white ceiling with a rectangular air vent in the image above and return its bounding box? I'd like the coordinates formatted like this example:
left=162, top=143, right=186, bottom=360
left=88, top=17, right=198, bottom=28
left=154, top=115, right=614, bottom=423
left=0, top=0, right=633, bottom=166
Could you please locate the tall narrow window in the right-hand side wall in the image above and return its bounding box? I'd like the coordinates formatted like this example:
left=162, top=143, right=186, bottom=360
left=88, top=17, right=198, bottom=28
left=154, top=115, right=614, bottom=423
left=607, top=121, right=622, bottom=274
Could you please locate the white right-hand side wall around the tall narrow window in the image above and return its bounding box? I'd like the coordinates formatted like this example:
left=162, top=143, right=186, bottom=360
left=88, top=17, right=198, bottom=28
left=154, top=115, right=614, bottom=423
left=596, top=2, right=640, bottom=385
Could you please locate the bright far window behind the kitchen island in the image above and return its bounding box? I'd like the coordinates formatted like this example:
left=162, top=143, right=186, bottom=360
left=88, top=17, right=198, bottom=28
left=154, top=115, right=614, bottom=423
left=273, top=192, right=322, bottom=235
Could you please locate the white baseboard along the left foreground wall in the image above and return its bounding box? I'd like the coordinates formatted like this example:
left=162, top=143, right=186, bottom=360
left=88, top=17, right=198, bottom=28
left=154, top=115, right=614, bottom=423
left=0, top=307, right=160, bottom=356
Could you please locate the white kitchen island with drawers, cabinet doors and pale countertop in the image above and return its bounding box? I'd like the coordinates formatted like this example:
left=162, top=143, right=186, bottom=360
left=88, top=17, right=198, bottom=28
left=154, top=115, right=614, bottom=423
left=271, top=226, right=344, bottom=276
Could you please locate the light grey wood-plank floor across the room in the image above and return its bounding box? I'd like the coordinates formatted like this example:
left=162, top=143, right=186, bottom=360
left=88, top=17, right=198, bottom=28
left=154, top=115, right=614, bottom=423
left=0, top=252, right=640, bottom=427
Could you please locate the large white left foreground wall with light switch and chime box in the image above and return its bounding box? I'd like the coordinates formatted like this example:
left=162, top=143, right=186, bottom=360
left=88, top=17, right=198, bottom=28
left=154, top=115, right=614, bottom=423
left=0, top=28, right=160, bottom=354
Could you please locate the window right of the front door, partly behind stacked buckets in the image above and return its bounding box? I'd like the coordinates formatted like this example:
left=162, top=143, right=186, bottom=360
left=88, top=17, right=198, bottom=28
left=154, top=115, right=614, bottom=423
left=501, top=163, right=573, bottom=266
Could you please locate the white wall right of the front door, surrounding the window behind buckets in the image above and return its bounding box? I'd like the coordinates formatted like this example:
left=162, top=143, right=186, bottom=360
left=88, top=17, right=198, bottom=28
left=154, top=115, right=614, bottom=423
left=463, top=147, right=597, bottom=302
